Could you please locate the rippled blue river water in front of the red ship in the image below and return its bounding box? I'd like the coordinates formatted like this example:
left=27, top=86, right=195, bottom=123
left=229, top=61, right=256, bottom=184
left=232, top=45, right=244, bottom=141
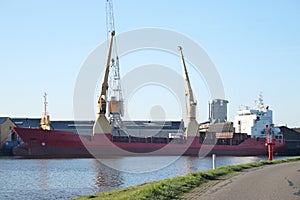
left=0, top=156, right=288, bottom=200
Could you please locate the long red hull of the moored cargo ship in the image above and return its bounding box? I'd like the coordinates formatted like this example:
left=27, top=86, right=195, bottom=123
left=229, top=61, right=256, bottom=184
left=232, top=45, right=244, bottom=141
left=14, top=128, right=284, bottom=158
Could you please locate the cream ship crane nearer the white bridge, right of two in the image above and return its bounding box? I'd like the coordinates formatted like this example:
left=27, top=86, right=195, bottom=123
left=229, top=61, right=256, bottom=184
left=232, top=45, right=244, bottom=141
left=178, top=46, right=199, bottom=138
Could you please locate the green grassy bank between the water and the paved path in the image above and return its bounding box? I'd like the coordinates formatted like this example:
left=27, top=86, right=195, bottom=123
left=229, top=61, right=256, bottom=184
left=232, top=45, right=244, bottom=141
left=74, top=157, right=300, bottom=200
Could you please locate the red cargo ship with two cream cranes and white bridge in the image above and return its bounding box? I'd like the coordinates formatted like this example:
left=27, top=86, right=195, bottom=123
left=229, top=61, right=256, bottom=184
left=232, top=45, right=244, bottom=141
left=13, top=1, right=284, bottom=157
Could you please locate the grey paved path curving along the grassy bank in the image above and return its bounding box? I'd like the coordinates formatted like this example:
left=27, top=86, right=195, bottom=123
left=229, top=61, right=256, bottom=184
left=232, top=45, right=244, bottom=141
left=182, top=161, right=300, bottom=200
